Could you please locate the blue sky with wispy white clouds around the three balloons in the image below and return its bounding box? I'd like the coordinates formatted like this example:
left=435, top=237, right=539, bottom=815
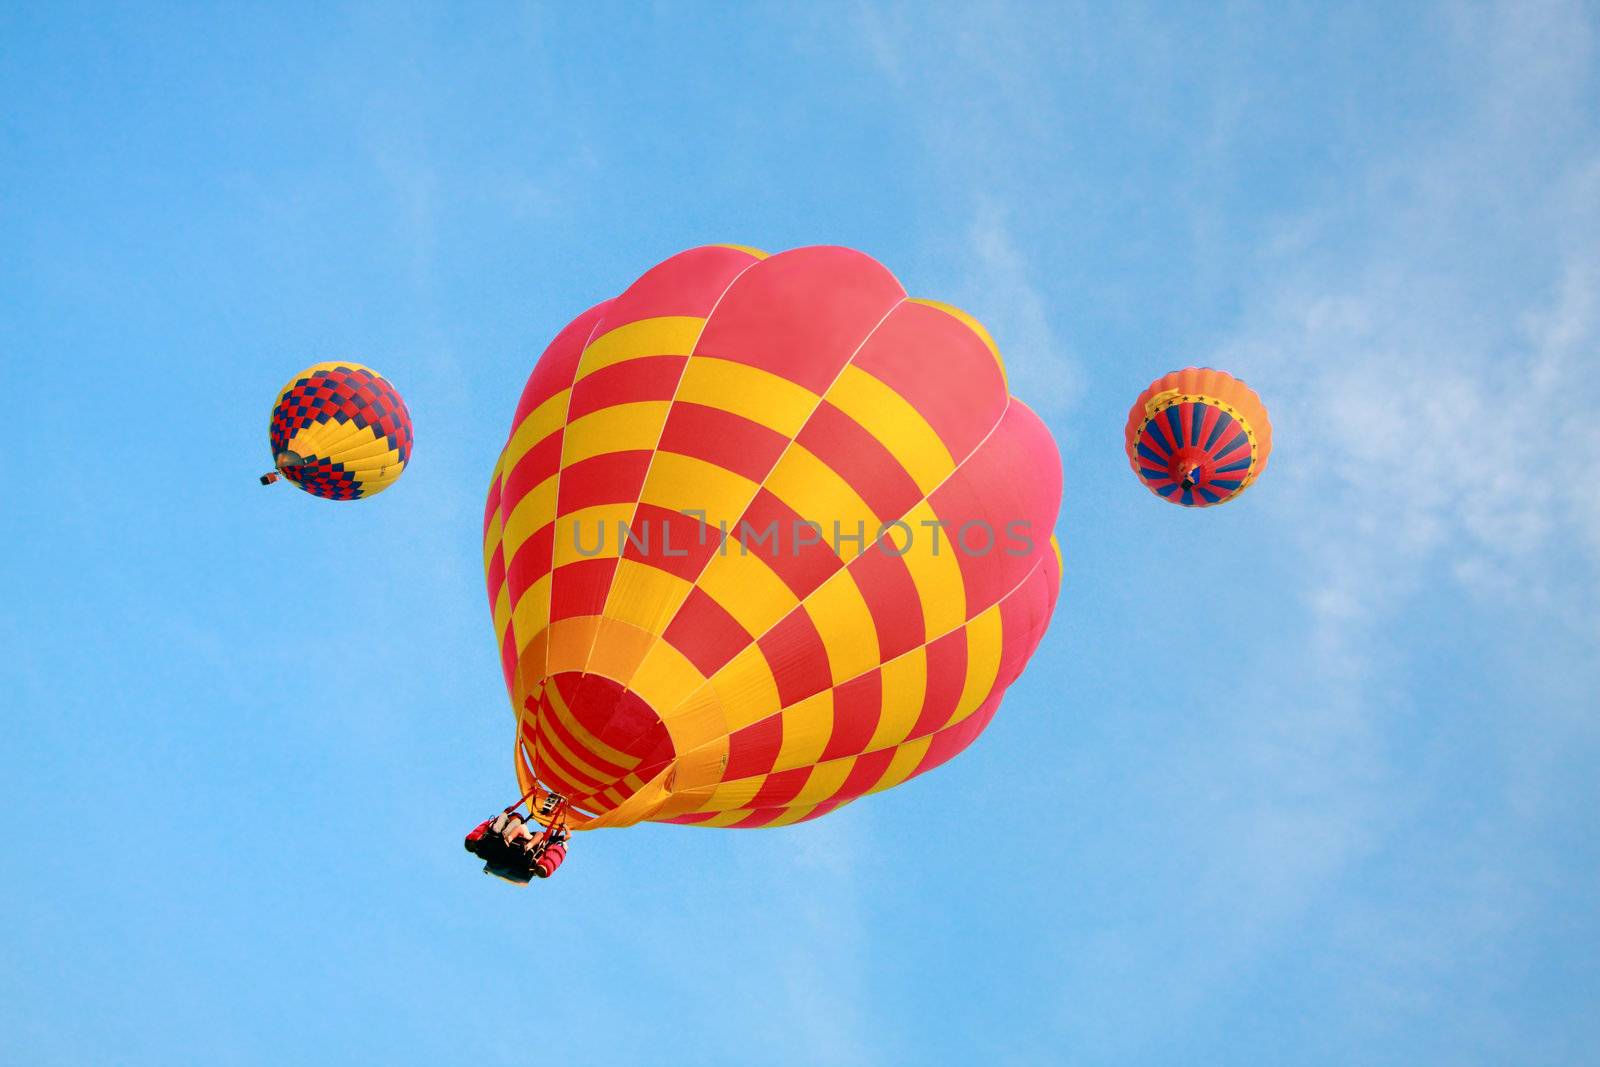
left=0, top=3, right=1600, bottom=1064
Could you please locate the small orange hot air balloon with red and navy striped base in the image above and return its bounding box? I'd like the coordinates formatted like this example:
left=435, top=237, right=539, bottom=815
left=1126, top=366, right=1272, bottom=507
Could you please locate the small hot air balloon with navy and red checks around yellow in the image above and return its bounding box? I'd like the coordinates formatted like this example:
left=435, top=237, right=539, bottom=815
left=261, top=363, right=411, bottom=501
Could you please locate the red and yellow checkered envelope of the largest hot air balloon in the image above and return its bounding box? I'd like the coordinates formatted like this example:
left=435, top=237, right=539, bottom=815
left=469, top=245, right=1061, bottom=881
